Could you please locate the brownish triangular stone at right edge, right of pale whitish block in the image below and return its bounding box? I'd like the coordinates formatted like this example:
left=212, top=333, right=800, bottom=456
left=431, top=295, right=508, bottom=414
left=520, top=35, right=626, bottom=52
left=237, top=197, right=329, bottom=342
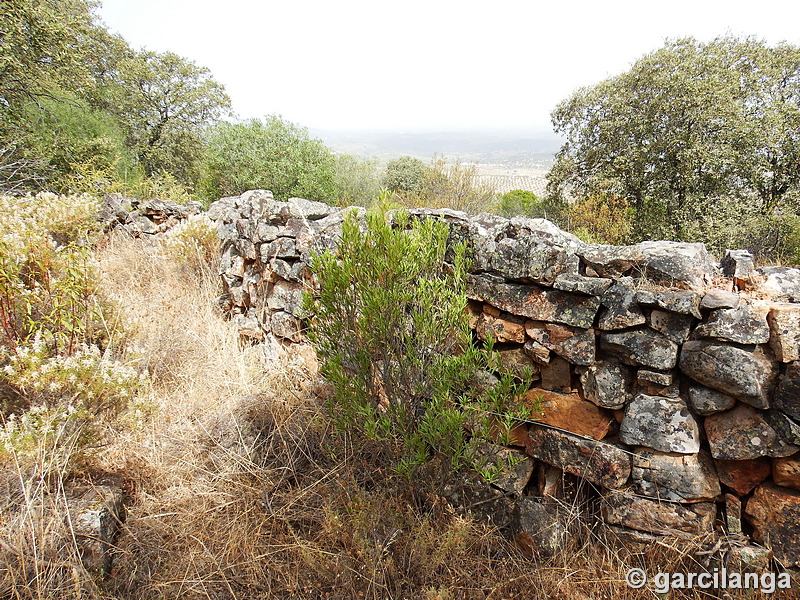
left=705, top=404, right=797, bottom=460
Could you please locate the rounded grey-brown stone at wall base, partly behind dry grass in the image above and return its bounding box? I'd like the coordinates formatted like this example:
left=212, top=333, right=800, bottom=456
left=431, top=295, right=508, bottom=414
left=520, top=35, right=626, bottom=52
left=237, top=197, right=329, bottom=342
left=511, top=496, right=567, bottom=557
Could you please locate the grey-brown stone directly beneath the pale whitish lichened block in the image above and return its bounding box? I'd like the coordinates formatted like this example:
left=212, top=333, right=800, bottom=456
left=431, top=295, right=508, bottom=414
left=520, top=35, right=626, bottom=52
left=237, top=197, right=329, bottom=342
left=631, top=448, right=721, bottom=503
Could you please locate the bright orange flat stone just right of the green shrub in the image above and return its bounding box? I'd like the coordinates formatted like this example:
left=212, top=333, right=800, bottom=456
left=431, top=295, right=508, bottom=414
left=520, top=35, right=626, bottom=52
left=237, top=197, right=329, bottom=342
left=525, top=389, right=614, bottom=440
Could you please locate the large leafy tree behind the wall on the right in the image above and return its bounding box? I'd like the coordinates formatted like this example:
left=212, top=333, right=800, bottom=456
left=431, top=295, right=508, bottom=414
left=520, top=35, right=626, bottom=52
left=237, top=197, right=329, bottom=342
left=549, top=37, right=800, bottom=243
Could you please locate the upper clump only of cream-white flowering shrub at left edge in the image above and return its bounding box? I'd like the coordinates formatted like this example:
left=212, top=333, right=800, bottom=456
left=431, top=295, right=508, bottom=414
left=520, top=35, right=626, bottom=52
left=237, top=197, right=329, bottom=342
left=0, top=193, right=109, bottom=354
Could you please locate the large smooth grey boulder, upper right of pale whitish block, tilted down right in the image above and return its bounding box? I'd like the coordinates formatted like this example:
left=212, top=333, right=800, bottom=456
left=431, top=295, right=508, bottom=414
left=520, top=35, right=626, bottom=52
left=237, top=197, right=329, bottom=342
left=680, top=341, right=778, bottom=408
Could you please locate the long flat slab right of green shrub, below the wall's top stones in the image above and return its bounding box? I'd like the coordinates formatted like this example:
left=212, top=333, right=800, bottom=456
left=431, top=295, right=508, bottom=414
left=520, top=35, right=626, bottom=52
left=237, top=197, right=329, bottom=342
left=467, top=275, right=600, bottom=329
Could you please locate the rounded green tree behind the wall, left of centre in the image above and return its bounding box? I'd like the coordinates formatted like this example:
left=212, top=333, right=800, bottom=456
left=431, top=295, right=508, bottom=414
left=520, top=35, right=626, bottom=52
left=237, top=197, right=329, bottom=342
left=202, top=115, right=337, bottom=202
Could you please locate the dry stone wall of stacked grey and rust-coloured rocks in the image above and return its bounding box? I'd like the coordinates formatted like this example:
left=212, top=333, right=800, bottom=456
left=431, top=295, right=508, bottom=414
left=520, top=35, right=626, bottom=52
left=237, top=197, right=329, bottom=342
left=210, top=190, right=800, bottom=567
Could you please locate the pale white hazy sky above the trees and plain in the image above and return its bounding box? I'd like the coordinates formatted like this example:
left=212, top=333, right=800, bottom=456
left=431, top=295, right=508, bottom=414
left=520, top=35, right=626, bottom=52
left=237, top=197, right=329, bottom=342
left=100, top=0, right=800, bottom=130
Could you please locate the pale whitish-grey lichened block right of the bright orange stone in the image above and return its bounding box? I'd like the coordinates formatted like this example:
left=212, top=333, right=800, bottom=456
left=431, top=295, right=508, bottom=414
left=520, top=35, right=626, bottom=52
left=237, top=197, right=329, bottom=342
left=619, top=394, right=700, bottom=454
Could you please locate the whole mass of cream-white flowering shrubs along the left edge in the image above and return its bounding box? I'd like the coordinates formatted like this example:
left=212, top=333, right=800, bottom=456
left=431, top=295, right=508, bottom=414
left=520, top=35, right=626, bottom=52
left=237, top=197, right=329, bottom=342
left=0, top=193, right=136, bottom=468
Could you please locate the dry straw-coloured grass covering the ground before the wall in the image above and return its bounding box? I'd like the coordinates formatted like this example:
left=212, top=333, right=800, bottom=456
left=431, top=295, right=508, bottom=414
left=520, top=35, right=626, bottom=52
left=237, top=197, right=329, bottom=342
left=0, top=232, right=784, bottom=600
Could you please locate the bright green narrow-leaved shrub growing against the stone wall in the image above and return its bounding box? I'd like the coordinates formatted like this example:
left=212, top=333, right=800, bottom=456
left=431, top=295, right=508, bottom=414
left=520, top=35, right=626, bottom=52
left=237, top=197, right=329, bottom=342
left=307, top=211, right=532, bottom=475
